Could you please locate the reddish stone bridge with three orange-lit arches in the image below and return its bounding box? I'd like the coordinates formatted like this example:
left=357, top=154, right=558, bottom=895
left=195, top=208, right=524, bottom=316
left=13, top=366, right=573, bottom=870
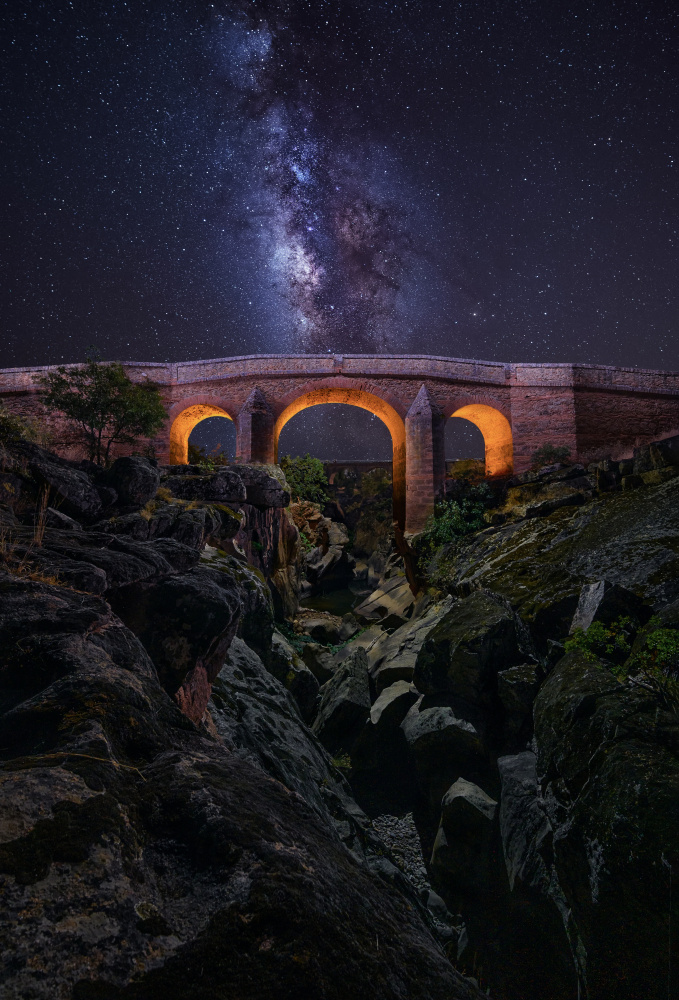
left=0, top=354, right=679, bottom=531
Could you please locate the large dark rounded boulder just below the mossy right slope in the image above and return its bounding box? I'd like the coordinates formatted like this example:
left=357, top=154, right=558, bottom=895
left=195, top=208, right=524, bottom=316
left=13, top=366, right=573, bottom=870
left=413, top=591, right=519, bottom=704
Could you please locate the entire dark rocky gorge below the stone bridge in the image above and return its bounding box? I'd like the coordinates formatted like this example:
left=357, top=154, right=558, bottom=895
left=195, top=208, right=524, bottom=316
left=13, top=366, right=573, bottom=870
left=0, top=439, right=679, bottom=1000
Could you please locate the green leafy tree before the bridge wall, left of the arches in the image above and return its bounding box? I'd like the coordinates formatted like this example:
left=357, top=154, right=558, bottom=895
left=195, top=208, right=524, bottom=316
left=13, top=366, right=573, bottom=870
left=38, top=358, right=167, bottom=466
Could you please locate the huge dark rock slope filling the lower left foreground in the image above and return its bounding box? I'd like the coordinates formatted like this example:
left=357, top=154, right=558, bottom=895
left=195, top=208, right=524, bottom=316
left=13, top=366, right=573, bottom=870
left=0, top=574, right=481, bottom=1000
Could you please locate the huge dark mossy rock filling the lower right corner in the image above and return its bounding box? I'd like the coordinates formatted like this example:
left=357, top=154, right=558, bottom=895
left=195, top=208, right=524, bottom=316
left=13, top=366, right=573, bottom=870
left=524, top=653, right=679, bottom=1000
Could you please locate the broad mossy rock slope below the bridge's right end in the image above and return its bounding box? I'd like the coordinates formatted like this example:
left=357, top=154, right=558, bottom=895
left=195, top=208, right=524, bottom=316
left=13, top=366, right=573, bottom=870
left=444, top=478, right=679, bottom=652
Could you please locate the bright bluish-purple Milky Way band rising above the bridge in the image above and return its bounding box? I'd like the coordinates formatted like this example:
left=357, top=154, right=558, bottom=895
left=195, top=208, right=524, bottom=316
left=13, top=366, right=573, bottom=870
left=212, top=4, right=415, bottom=351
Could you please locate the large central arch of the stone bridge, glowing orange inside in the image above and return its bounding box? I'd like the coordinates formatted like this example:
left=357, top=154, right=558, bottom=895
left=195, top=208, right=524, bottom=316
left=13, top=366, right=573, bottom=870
left=274, top=386, right=406, bottom=528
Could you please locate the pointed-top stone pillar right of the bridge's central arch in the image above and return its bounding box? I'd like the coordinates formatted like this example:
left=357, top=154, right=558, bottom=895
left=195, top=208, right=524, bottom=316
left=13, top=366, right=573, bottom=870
left=405, top=385, right=446, bottom=532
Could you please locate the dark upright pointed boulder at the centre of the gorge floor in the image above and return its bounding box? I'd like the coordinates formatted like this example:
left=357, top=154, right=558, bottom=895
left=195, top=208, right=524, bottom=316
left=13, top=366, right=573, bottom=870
left=312, top=647, right=370, bottom=753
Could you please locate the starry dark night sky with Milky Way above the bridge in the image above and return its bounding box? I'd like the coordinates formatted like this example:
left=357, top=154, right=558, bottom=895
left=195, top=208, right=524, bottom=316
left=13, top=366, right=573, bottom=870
left=0, top=0, right=679, bottom=457
